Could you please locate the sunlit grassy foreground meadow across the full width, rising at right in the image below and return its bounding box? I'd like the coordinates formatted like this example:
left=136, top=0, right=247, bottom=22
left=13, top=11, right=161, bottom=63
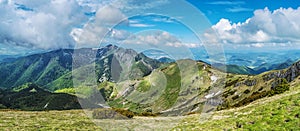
left=0, top=86, right=300, bottom=130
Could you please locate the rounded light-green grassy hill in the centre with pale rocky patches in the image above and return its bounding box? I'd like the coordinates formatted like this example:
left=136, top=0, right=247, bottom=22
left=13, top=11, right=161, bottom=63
left=104, top=60, right=211, bottom=114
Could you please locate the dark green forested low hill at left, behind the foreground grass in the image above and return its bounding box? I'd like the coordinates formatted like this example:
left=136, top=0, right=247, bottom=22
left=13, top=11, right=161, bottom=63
left=0, top=83, right=86, bottom=110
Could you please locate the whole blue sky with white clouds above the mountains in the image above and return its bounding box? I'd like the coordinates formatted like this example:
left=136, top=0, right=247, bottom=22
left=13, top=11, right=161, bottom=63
left=0, top=0, right=300, bottom=55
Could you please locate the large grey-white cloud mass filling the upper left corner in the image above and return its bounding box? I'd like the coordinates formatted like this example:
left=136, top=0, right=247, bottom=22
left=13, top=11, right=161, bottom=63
left=0, top=0, right=88, bottom=49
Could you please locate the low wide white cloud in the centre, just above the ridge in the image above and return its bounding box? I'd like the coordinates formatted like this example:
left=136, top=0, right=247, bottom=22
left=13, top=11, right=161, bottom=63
left=118, top=30, right=201, bottom=59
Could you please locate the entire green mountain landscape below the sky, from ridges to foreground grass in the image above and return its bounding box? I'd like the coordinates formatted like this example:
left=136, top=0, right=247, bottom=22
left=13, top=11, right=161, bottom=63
left=0, top=45, right=300, bottom=130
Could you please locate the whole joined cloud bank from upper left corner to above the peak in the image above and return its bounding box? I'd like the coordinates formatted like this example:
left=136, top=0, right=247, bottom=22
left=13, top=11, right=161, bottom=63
left=0, top=0, right=173, bottom=50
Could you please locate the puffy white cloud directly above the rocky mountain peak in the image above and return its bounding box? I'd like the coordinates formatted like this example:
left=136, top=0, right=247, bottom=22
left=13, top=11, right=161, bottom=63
left=70, top=5, right=128, bottom=48
